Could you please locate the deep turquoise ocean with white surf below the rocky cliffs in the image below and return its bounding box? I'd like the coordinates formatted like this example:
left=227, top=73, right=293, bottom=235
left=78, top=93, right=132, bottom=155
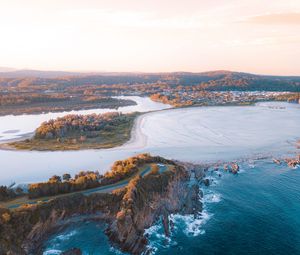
left=43, top=160, right=300, bottom=255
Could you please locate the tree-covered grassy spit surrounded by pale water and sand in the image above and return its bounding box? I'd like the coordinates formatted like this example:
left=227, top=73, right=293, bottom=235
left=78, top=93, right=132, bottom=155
left=8, top=112, right=138, bottom=150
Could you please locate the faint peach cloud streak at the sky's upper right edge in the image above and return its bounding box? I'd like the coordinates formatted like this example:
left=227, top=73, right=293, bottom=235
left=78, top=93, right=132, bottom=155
left=242, top=12, right=300, bottom=25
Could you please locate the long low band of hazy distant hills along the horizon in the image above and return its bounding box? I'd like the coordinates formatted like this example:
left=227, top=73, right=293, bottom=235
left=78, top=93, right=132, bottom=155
left=0, top=70, right=300, bottom=91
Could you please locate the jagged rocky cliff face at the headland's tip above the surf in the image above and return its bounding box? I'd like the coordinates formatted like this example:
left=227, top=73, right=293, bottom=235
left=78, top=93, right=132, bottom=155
left=107, top=165, right=202, bottom=254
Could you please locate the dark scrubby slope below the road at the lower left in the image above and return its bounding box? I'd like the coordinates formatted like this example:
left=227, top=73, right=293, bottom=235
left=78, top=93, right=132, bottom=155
left=0, top=193, right=123, bottom=255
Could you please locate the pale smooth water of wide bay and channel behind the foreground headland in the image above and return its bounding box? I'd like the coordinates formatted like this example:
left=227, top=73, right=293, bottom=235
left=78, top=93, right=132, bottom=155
left=0, top=99, right=300, bottom=184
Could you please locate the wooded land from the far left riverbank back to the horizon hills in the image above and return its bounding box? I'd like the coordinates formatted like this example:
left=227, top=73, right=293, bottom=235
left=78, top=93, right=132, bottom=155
left=0, top=71, right=300, bottom=115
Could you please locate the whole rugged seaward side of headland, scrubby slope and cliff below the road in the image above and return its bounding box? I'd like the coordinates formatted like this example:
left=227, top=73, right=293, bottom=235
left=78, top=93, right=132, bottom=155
left=0, top=157, right=202, bottom=255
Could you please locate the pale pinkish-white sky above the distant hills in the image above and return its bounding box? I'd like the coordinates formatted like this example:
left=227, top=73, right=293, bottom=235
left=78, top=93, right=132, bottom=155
left=0, top=0, right=300, bottom=75
